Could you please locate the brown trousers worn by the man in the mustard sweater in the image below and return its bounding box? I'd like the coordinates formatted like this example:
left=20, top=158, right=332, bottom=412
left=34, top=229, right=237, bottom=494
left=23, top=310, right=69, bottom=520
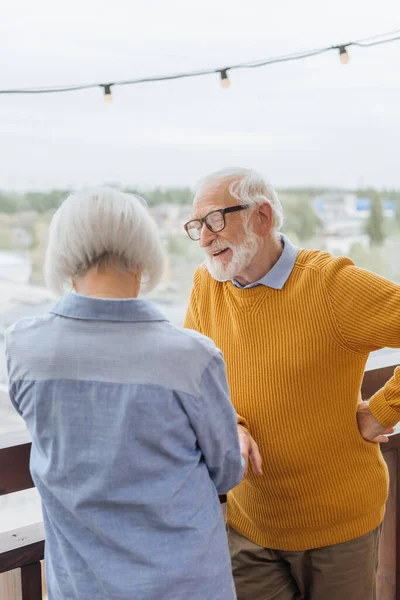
left=228, top=526, right=381, bottom=600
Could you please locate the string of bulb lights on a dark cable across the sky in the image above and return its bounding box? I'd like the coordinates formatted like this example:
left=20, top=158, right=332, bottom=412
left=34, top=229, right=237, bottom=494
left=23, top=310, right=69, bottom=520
left=0, top=29, right=400, bottom=103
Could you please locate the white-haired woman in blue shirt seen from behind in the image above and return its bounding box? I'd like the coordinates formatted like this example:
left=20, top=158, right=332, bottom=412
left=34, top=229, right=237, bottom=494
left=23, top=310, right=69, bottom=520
left=6, top=188, right=243, bottom=600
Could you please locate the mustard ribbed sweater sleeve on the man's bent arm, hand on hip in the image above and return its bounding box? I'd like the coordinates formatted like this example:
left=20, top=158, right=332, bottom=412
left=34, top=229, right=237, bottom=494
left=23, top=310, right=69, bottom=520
left=324, top=258, right=400, bottom=427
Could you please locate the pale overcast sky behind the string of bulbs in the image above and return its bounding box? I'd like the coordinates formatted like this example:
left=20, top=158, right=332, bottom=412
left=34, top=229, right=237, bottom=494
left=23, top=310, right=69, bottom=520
left=0, top=0, right=400, bottom=191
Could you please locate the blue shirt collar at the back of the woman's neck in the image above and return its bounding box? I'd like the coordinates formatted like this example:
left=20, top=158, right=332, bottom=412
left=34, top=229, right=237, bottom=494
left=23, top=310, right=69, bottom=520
left=50, top=292, right=167, bottom=322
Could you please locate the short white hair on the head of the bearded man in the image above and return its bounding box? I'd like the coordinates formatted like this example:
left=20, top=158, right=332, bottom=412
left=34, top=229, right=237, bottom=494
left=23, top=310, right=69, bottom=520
left=196, top=167, right=283, bottom=231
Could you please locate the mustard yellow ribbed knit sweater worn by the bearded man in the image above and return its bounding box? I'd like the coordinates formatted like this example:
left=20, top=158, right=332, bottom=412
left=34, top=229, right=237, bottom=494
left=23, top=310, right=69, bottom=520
left=185, top=250, right=400, bottom=550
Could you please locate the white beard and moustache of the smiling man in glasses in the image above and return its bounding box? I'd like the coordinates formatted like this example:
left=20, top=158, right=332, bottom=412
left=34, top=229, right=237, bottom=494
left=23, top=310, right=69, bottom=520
left=206, top=231, right=259, bottom=281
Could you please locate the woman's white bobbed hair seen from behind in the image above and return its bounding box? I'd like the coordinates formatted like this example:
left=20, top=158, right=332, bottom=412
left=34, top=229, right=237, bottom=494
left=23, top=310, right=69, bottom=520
left=44, top=187, right=164, bottom=294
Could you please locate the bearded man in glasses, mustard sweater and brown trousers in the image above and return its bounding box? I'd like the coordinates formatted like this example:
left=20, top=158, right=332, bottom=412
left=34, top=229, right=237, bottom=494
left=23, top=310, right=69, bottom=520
left=185, top=169, right=400, bottom=600
